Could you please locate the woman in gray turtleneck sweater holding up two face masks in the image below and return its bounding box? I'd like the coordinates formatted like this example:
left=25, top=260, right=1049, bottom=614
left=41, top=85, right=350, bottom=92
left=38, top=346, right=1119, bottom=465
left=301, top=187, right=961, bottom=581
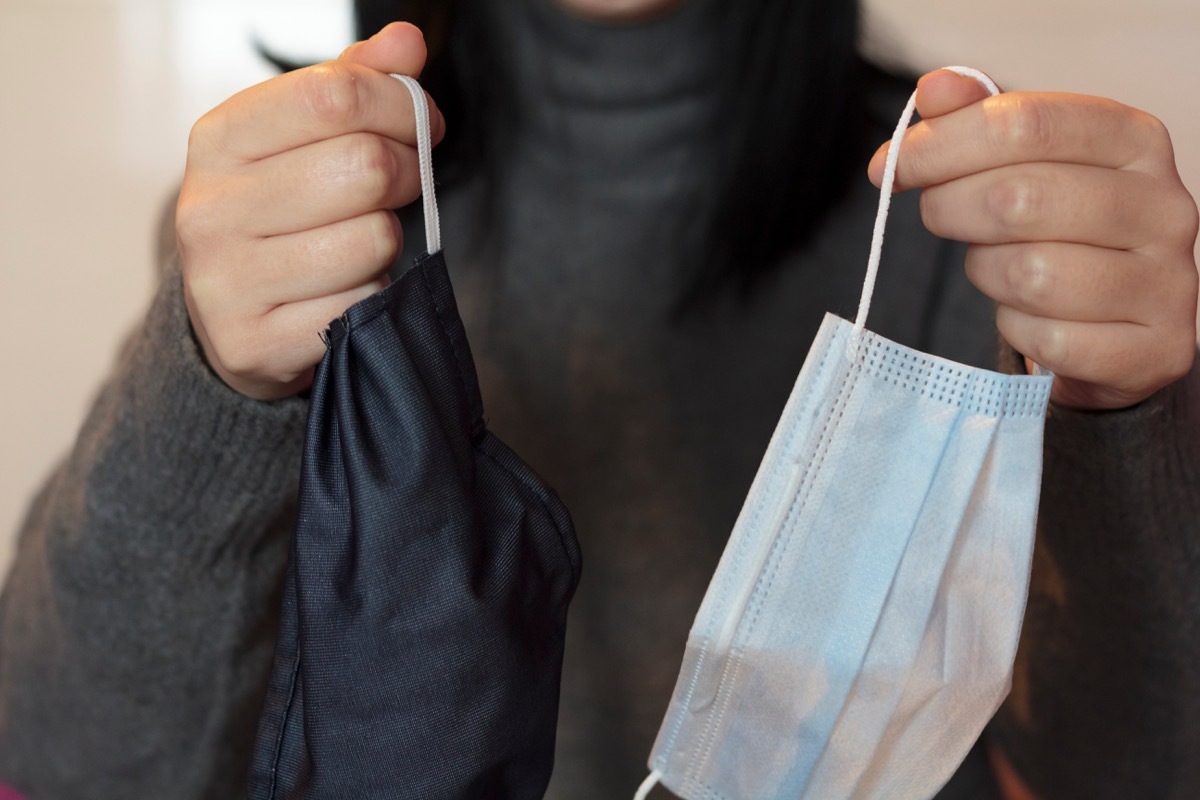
left=0, top=0, right=1200, bottom=798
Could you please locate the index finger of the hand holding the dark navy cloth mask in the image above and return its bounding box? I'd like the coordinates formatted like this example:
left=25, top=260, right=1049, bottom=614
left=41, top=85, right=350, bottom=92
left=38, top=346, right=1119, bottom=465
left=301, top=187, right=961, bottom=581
left=190, top=61, right=444, bottom=163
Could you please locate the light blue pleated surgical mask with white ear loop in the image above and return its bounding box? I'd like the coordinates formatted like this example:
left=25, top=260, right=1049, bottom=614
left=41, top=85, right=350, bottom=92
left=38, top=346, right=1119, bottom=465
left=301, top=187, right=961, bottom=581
left=640, top=68, right=1052, bottom=800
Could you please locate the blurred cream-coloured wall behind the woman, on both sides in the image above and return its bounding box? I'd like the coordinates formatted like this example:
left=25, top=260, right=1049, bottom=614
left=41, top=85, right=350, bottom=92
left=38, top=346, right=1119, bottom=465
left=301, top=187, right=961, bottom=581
left=0, top=0, right=1200, bottom=573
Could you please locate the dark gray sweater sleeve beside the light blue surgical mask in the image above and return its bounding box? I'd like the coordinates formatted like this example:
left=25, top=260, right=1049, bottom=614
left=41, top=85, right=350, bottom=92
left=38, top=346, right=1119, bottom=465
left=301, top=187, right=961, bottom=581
left=994, top=362, right=1200, bottom=800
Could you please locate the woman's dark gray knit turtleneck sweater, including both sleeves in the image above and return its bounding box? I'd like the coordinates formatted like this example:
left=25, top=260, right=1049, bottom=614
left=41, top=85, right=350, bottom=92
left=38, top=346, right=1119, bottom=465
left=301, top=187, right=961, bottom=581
left=0, top=0, right=1200, bottom=800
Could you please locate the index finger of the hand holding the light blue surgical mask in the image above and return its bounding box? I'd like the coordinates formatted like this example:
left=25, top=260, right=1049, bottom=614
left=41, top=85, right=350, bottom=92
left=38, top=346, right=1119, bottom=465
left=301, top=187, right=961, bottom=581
left=896, top=91, right=1174, bottom=191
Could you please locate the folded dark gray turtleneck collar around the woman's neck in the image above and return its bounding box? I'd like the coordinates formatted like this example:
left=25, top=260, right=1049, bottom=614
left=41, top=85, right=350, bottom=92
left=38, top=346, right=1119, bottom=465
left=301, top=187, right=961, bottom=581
left=477, top=0, right=721, bottom=201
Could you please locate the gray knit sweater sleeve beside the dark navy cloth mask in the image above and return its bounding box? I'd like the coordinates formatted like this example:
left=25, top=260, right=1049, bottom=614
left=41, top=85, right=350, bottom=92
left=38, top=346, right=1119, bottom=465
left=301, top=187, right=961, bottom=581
left=0, top=253, right=306, bottom=800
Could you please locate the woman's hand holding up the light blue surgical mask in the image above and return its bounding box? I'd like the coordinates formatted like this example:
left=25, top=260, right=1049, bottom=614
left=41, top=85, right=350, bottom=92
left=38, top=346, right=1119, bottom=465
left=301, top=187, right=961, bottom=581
left=869, top=70, right=1198, bottom=409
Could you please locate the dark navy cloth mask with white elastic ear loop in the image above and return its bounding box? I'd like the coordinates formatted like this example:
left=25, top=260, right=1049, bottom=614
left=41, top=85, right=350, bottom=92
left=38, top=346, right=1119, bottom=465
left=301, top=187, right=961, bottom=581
left=250, top=79, right=580, bottom=800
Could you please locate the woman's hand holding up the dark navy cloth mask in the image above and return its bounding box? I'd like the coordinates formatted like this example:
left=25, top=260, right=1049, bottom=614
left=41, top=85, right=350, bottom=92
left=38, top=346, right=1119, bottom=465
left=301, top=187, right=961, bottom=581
left=175, top=23, right=444, bottom=399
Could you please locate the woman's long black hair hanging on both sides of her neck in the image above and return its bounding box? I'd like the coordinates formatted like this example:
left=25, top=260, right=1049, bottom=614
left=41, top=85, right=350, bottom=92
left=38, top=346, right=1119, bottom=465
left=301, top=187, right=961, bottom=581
left=355, top=0, right=872, bottom=301
